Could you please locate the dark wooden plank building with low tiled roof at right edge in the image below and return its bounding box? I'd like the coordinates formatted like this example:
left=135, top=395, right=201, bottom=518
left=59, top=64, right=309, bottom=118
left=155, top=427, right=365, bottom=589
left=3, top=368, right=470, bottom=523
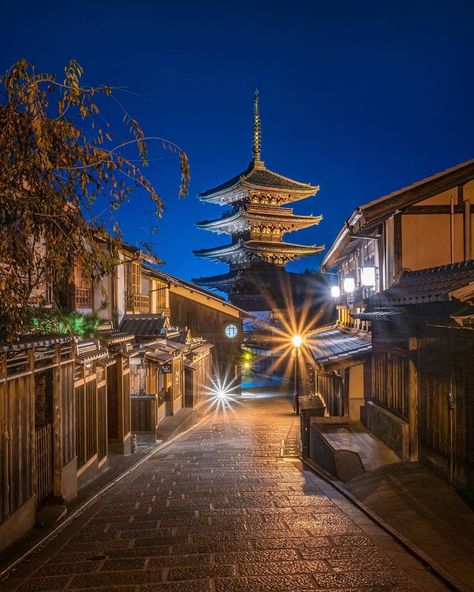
left=360, top=259, right=474, bottom=489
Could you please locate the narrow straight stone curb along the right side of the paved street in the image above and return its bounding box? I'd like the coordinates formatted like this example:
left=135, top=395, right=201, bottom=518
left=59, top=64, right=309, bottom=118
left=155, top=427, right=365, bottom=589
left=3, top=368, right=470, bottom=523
left=301, top=457, right=472, bottom=592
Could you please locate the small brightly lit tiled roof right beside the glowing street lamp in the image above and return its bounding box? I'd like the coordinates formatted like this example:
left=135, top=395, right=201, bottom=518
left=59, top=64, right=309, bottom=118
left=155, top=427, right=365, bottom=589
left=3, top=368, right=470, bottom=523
left=307, top=327, right=372, bottom=364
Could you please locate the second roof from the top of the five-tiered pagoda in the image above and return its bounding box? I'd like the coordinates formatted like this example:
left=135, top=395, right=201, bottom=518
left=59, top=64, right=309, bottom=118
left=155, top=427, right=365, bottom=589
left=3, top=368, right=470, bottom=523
left=196, top=208, right=322, bottom=232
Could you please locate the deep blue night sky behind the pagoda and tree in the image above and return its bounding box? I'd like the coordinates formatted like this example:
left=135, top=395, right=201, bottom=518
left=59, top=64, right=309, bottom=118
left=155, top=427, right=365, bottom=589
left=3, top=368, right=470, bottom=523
left=0, top=0, right=474, bottom=278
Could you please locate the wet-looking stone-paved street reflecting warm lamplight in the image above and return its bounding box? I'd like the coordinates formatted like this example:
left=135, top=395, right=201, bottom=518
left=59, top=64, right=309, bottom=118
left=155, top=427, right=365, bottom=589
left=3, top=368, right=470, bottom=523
left=1, top=391, right=445, bottom=592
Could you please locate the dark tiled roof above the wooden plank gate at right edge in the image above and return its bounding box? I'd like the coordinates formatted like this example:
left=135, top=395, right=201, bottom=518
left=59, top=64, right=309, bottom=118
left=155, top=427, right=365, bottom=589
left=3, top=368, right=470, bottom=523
left=367, top=259, right=474, bottom=308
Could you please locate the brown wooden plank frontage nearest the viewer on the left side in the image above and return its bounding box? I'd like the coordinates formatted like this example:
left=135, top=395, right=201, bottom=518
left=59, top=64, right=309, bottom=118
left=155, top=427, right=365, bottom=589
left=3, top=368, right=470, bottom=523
left=0, top=336, right=77, bottom=550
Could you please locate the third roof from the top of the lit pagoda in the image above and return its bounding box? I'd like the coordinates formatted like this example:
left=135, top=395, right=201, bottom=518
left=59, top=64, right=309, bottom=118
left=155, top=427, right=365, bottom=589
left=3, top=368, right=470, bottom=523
left=194, top=239, right=324, bottom=262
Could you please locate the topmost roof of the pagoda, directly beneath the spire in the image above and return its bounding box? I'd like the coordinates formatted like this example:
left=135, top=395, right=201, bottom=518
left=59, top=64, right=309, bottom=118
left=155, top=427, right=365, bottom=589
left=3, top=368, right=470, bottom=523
left=199, top=159, right=319, bottom=203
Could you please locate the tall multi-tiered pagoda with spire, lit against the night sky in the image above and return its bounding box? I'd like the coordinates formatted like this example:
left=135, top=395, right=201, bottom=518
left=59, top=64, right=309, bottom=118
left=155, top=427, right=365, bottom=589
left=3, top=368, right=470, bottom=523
left=194, top=91, right=324, bottom=310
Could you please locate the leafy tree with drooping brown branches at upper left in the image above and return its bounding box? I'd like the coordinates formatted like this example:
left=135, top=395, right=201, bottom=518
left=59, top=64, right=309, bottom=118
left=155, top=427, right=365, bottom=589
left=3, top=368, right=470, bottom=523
left=0, top=60, right=189, bottom=341
